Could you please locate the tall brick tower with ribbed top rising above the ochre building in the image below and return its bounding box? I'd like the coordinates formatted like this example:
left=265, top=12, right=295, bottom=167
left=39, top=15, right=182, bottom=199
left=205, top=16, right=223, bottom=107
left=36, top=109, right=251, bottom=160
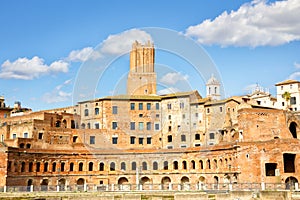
left=127, top=41, right=156, bottom=95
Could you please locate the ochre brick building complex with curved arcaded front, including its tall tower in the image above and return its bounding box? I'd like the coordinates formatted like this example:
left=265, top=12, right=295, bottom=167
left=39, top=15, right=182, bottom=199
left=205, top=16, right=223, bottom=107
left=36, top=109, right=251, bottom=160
left=0, top=42, right=300, bottom=189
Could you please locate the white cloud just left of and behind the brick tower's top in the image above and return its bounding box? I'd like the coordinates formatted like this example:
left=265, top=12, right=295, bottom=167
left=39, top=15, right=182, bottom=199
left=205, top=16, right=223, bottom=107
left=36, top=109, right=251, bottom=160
left=101, top=29, right=152, bottom=54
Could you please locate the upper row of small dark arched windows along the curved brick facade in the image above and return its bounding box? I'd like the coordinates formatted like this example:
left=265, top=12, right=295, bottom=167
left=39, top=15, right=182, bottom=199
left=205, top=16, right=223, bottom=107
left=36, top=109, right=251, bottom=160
left=8, top=158, right=231, bottom=172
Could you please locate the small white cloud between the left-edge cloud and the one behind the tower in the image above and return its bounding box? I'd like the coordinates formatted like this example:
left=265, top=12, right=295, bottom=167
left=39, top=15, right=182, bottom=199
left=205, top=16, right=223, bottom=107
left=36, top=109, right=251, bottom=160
left=67, top=47, right=101, bottom=62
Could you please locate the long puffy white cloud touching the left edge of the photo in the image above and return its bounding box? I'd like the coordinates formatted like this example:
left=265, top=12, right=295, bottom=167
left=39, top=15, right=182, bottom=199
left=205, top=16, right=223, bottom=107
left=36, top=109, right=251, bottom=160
left=0, top=56, right=69, bottom=80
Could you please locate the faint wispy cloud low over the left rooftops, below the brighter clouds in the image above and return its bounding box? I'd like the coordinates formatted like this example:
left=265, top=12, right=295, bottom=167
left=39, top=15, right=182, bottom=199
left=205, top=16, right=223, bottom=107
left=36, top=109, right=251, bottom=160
left=42, top=79, right=72, bottom=104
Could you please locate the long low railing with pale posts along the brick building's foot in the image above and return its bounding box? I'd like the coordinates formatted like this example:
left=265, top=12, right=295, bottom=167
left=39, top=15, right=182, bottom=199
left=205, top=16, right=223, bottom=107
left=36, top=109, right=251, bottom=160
left=0, top=183, right=300, bottom=192
